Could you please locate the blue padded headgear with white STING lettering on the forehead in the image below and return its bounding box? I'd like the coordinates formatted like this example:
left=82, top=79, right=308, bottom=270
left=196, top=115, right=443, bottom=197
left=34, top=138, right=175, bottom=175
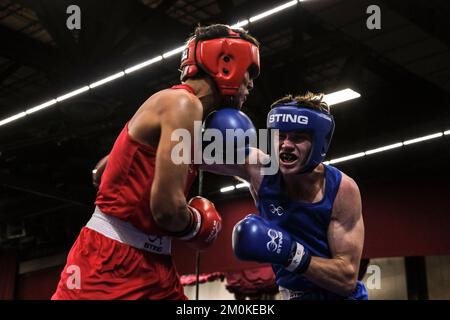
left=267, top=101, right=334, bottom=173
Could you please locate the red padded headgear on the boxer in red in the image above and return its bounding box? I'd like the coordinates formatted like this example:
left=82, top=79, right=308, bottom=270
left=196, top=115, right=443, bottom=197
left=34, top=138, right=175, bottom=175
left=180, top=29, right=260, bottom=105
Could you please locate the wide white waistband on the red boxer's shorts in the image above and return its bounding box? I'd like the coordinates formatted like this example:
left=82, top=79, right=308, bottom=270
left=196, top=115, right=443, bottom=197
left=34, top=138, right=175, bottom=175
left=86, top=207, right=172, bottom=254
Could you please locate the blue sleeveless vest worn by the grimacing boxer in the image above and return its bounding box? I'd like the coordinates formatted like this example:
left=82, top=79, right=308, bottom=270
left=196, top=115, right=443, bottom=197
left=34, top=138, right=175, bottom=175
left=257, top=165, right=368, bottom=300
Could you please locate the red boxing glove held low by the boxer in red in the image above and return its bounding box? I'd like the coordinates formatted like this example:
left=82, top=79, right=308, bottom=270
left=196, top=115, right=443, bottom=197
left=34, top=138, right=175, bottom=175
left=180, top=197, right=222, bottom=251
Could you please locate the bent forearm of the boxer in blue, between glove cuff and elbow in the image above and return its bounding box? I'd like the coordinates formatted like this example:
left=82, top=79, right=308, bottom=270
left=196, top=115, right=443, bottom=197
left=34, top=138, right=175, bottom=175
left=303, top=257, right=358, bottom=296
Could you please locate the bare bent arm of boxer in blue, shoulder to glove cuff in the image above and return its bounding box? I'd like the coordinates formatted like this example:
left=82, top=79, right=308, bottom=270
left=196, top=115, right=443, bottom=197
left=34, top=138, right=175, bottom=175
left=304, top=174, right=364, bottom=296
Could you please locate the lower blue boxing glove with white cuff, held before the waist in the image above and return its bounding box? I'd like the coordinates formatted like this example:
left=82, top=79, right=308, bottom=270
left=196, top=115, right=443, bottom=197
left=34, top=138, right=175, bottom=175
left=233, top=214, right=311, bottom=273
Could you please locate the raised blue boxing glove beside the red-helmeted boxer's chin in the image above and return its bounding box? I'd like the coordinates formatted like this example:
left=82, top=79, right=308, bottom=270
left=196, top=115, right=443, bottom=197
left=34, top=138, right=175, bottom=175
left=203, top=108, right=257, bottom=164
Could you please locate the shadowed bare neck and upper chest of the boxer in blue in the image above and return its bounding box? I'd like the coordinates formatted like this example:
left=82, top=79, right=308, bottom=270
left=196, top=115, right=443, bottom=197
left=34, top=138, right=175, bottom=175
left=283, top=165, right=325, bottom=203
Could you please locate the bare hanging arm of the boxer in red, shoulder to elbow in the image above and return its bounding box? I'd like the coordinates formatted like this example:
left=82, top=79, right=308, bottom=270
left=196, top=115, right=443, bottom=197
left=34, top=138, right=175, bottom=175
left=150, top=95, right=203, bottom=232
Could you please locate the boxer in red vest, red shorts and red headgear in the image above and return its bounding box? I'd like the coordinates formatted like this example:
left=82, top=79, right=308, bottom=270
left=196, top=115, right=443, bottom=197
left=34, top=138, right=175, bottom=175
left=52, top=25, right=259, bottom=300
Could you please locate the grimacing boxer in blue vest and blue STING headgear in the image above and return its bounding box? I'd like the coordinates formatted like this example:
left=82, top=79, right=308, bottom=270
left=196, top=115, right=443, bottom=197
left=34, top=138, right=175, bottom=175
left=205, top=93, right=368, bottom=300
